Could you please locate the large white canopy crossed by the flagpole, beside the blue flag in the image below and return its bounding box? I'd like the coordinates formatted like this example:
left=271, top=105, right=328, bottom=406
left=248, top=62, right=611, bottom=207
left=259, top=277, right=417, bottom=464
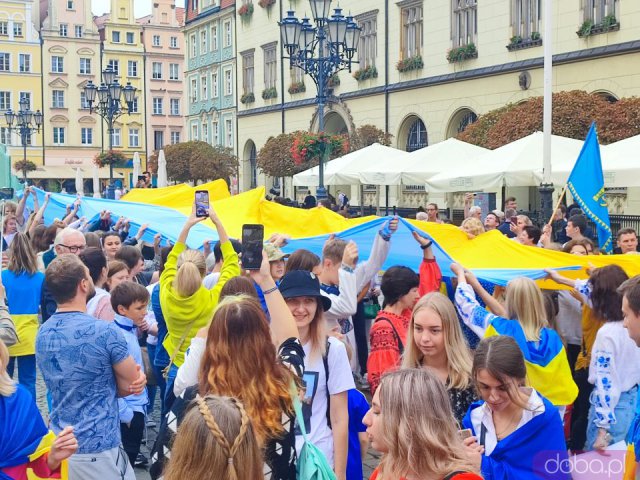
left=426, top=132, right=583, bottom=192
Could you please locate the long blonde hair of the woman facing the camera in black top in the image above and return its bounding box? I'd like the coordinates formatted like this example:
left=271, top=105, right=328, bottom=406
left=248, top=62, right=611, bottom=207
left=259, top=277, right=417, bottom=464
left=402, top=292, right=472, bottom=389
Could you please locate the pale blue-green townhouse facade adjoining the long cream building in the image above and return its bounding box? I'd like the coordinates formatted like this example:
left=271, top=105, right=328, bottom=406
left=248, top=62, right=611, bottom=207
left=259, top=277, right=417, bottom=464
left=184, top=0, right=237, bottom=159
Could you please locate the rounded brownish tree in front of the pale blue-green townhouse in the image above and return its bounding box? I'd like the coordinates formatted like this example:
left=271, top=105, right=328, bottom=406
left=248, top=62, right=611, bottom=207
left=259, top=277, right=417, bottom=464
left=164, top=141, right=238, bottom=182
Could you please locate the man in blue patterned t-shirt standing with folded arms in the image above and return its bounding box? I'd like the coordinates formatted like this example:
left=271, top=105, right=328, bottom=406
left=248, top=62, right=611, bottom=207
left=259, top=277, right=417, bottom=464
left=36, top=254, right=146, bottom=480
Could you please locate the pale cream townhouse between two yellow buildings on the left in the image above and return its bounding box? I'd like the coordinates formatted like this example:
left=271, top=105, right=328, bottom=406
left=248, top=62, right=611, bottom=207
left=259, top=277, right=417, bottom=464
left=40, top=0, right=103, bottom=178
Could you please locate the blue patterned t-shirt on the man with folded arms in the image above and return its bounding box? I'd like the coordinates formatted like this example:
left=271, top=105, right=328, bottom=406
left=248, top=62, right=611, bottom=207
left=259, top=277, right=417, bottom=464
left=36, top=312, right=129, bottom=453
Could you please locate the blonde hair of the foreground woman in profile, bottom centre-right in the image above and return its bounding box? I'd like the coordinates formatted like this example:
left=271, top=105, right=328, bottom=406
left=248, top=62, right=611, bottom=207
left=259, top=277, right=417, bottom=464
left=378, top=368, right=476, bottom=480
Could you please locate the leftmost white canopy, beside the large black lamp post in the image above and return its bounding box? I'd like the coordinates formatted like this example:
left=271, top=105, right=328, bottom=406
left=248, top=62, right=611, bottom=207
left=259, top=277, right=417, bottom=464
left=293, top=143, right=407, bottom=187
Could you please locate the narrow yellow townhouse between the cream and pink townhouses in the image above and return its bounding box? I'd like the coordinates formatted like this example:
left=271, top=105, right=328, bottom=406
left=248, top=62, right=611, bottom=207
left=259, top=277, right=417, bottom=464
left=96, top=0, right=147, bottom=172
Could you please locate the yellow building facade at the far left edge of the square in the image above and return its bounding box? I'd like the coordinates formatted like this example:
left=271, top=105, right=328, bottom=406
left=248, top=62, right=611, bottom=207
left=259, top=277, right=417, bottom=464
left=0, top=0, right=43, bottom=169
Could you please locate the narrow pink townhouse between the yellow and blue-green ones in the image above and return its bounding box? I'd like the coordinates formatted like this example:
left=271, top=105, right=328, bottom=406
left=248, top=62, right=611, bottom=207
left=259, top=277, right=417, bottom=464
left=138, top=0, right=182, bottom=161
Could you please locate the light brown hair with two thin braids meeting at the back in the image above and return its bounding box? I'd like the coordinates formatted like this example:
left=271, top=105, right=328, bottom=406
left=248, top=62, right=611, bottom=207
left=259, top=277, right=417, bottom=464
left=164, top=395, right=262, bottom=480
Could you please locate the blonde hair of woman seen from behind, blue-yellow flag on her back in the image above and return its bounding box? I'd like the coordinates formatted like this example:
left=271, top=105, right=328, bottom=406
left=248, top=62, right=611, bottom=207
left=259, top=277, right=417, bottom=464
left=504, top=277, right=549, bottom=342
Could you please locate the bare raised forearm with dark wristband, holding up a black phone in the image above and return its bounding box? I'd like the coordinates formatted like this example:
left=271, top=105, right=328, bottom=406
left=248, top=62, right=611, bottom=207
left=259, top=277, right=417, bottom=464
left=250, top=251, right=299, bottom=347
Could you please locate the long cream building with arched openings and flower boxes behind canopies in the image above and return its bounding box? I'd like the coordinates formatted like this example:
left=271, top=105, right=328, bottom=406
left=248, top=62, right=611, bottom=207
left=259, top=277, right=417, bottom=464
left=238, top=0, right=640, bottom=213
